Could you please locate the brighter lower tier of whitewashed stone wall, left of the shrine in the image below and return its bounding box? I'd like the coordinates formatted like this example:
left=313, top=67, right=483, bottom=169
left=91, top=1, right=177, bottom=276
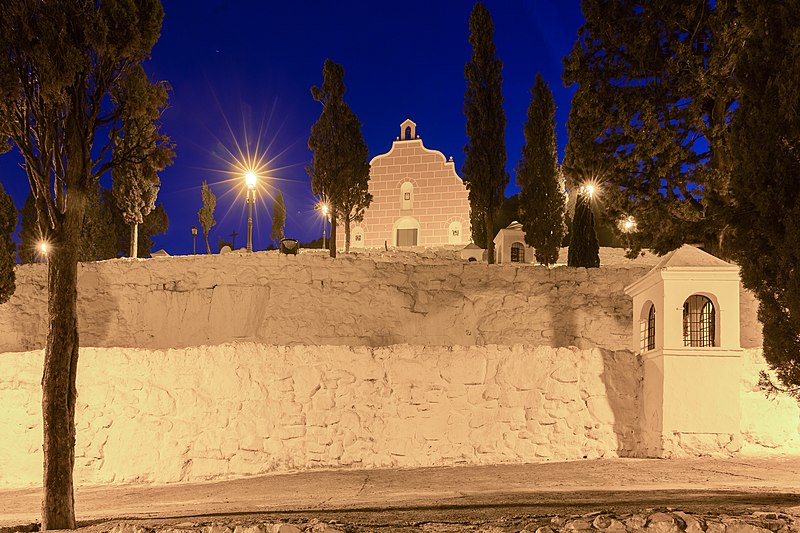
left=0, top=343, right=640, bottom=487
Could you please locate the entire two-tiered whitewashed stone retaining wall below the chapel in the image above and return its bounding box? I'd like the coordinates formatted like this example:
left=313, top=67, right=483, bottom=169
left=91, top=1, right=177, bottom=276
left=0, top=247, right=800, bottom=487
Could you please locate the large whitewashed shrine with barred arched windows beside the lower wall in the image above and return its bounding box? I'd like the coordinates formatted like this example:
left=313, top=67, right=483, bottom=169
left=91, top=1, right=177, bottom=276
left=625, top=245, right=742, bottom=457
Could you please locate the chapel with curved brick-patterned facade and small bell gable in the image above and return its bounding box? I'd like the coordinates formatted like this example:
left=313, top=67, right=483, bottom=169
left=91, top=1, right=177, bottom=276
left=337, top=119, right=472, bottom=249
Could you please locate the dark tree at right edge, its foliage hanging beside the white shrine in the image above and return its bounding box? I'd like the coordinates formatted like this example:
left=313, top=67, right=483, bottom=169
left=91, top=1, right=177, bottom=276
left=729, top=0, right=800, bottom=399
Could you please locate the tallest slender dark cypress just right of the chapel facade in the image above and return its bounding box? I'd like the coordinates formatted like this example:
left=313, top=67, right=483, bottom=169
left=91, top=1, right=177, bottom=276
left=461, top=2, right=508, bottom=264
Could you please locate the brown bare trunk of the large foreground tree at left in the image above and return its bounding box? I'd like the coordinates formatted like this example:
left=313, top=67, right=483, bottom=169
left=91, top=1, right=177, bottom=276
left=42, top=187, right=86, bottom=531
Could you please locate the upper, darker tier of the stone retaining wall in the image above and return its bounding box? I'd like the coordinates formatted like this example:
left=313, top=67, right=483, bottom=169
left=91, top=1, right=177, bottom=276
left=0, top=252, right=761, bottom=353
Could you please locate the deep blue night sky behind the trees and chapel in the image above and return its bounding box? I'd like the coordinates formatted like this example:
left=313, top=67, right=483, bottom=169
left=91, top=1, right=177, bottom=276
left=0, top=0, right=583, bottom=255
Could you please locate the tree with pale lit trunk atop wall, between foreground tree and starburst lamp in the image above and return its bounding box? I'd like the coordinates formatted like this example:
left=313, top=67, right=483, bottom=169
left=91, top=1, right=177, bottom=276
left=111, top=65, right=175, bottom=257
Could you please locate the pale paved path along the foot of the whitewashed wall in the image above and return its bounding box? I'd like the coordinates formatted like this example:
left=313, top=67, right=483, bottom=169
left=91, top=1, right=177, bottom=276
left=0, top=458, right=800, bottom=526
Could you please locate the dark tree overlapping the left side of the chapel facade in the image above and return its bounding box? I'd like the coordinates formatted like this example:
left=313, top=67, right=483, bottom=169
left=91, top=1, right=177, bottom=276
left=306, top=59, right=372, bottom=257
